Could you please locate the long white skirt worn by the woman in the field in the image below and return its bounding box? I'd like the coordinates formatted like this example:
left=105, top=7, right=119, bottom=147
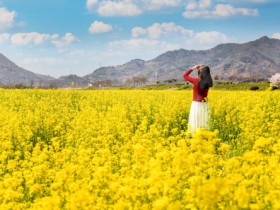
left=188, top=101, right=210, bottom=136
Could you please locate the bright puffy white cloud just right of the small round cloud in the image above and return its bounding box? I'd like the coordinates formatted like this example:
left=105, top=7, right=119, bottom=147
left=132, top=22, right=193, bottom=39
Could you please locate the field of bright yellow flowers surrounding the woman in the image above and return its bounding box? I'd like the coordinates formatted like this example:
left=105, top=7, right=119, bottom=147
left=0, top=89, right=280, bottom=210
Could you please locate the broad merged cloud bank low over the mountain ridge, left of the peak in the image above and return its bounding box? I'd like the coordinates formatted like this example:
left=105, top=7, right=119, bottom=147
left=109, top=23, right=233, bottom=58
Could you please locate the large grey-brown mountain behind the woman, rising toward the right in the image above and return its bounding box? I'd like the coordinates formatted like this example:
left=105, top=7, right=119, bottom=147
left=84, top=36, right=280, bottom=84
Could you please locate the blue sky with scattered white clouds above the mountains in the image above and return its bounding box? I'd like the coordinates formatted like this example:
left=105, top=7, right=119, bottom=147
left=0, top=0, right=280, bottom=78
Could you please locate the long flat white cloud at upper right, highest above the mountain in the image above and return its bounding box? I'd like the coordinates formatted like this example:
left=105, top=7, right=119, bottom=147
left=183, top=4, right=259, bottom=18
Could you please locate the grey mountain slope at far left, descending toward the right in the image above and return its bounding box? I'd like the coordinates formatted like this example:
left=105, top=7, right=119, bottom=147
left=0, top=53, right=55, bottom=86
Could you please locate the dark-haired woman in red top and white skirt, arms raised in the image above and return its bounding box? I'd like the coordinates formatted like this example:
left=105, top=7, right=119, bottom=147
left=183, top=65, right=213, bottom=136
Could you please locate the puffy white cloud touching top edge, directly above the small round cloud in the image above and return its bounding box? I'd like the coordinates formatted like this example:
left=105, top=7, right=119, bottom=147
left=97, top=1, right=142, bottom=16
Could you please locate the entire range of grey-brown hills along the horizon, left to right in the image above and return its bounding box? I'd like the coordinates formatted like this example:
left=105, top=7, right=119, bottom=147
left=0, top=36, right=280, bottom=87
